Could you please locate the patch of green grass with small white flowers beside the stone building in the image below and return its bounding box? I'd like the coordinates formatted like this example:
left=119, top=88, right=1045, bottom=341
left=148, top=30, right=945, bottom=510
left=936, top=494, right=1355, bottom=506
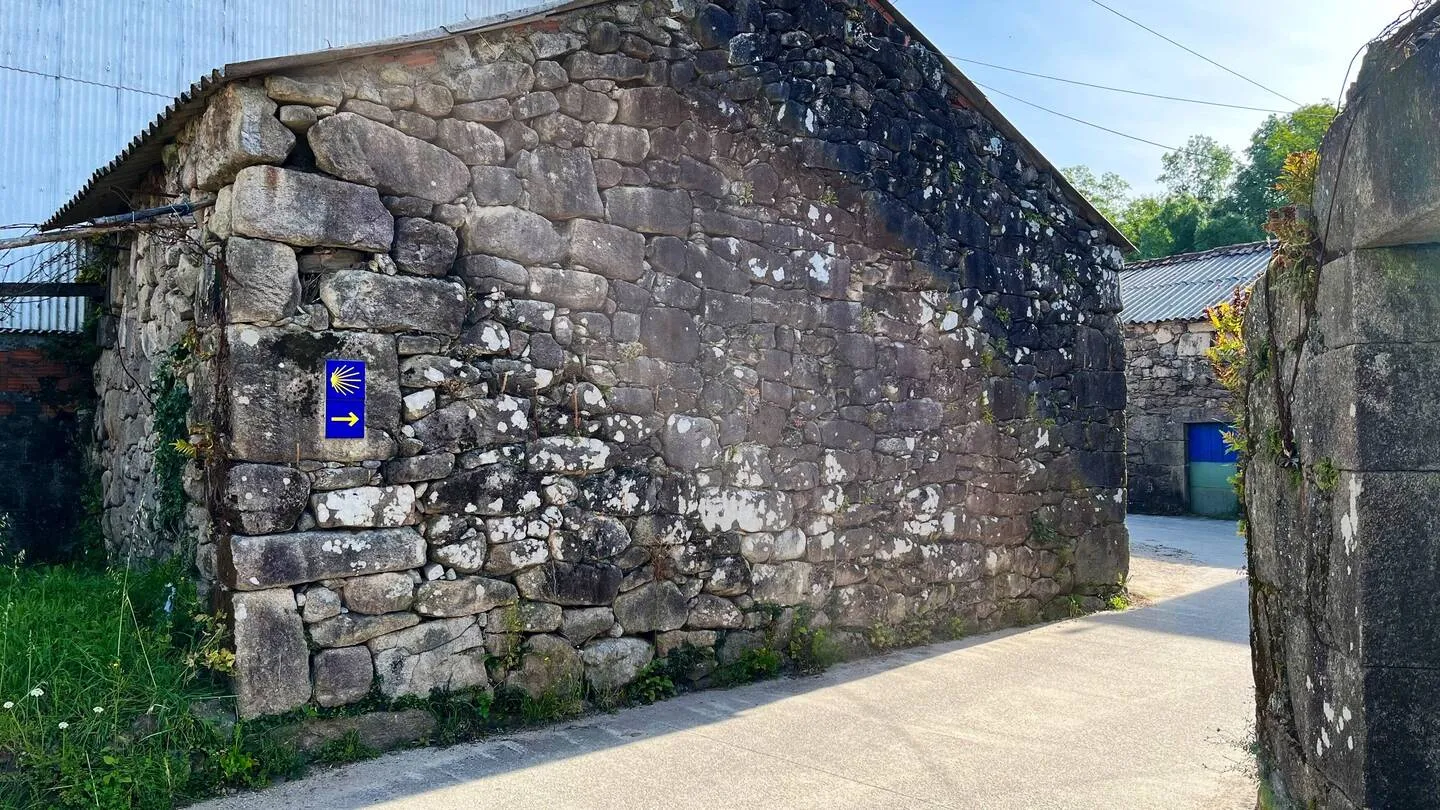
left=0, top=566, right=239, bottom=809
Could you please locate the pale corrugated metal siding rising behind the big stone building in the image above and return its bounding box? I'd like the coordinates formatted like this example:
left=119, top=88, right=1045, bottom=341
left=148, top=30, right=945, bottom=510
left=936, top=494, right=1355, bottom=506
left=0, top=0, right=536, bottom=330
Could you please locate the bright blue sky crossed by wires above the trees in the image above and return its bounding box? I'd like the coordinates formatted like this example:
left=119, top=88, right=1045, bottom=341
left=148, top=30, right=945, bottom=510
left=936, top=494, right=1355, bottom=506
left=894, top=0, right=1411, bottom=193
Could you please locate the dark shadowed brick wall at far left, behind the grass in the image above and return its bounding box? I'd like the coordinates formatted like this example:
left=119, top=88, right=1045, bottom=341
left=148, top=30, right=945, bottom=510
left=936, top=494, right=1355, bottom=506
left=0, top=333, right=94, bottom=562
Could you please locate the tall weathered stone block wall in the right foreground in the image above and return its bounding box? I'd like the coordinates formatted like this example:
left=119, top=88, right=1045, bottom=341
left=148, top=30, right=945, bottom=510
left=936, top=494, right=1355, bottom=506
left=1246, top=9, right=1440, bottom=809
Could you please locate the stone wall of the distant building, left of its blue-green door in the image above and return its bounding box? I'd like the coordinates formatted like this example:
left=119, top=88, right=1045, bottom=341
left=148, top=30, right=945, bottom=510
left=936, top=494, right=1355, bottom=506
left=1125, top=320, right=1231, bottom=515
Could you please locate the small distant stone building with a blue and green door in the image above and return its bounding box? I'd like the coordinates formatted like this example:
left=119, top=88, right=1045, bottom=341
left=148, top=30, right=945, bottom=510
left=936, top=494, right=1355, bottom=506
left=1120, top=242, right=1270, bottom=517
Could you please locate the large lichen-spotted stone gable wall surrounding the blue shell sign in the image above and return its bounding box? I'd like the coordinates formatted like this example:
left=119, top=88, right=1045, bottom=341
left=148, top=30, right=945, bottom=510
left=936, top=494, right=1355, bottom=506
left=98, top=0, right=1128, bottom=715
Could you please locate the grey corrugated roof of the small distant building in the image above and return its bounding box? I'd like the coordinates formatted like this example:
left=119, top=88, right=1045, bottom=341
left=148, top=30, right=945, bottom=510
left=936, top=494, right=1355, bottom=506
left=1120, top=242, right=1273, bottom=323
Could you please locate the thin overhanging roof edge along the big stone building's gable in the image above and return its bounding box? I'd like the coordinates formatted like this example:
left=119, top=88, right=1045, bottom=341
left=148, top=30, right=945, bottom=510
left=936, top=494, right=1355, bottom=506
left=43, top=0, right=1135, bottom=251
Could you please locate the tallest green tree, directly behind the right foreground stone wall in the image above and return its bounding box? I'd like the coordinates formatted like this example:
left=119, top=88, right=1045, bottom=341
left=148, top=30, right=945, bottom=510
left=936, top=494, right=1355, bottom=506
left=1223, top=104, right=1336, bottom=232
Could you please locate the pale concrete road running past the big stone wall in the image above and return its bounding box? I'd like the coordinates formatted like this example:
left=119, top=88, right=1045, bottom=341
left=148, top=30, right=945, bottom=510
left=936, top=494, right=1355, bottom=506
left=204, top=517, right=1254, bottom=810
